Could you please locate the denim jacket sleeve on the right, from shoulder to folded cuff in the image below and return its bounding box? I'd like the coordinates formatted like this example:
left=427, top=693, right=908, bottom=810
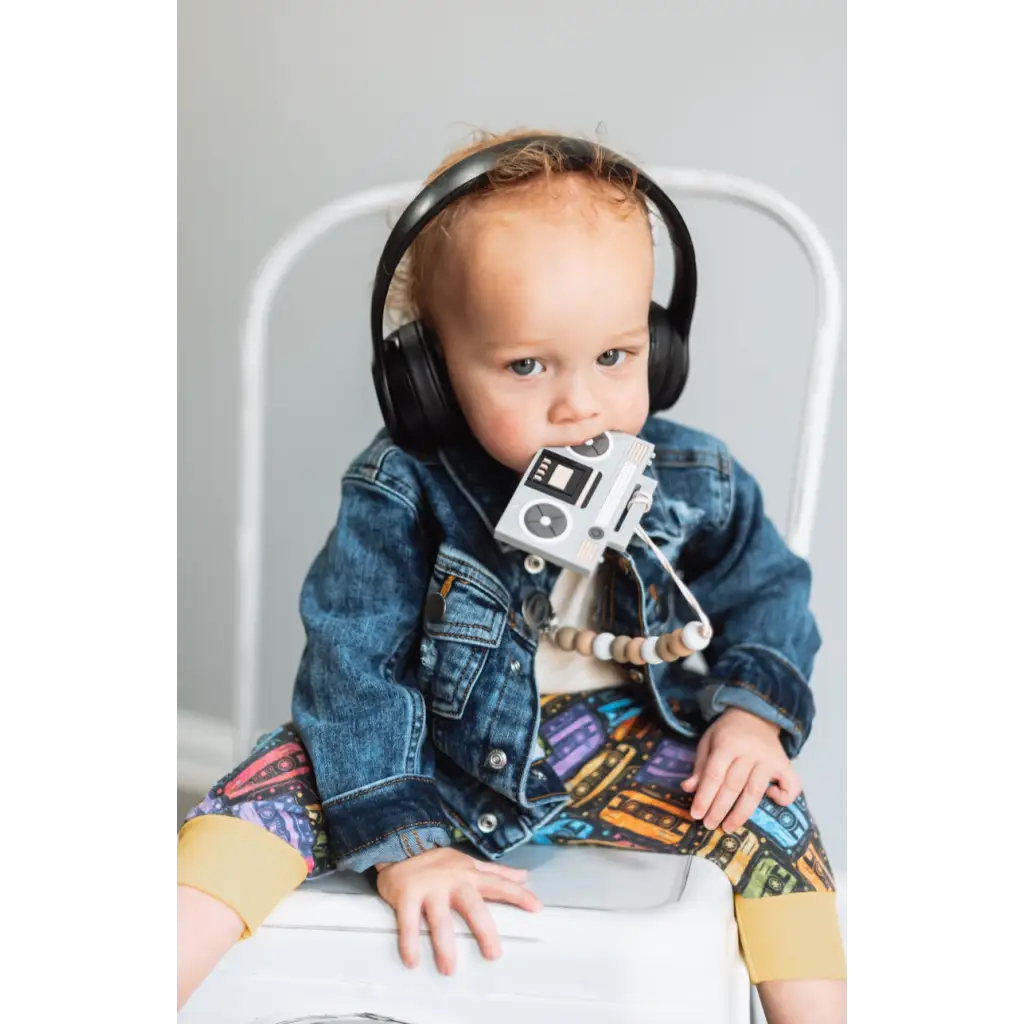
left=689, top=452, right=821, bottom=758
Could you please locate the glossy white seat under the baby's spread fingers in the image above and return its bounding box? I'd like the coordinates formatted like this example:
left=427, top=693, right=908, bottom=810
left=178, top=846, right=751, bottom=1024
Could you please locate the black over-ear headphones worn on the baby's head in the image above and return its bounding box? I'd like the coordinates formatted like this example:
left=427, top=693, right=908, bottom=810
left=371, top=135, right=697, bottom=452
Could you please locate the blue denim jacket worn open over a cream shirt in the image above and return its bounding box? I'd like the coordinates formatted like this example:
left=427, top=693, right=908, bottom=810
left=293, top=417, right=820, bottom=871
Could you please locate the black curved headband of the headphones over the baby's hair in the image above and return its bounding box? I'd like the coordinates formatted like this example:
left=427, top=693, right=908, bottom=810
left=370, top=135, right=696, bottom=362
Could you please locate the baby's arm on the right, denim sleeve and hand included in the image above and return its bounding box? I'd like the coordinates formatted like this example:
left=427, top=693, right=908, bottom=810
left=683, top=452, right=820, bottom=830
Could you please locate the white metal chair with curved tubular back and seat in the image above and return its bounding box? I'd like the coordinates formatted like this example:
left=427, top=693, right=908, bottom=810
left=190, top=167, right=841, bottom=1024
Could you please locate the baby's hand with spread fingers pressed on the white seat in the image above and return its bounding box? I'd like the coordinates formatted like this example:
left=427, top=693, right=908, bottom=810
left=377, top=847, right=542, bottom=974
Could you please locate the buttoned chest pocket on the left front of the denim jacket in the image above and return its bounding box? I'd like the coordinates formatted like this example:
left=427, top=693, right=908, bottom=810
left=420, top=543, right=510, bottom=718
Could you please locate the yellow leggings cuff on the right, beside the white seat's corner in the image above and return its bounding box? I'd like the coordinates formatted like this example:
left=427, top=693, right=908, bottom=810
left=736, top=892, right=847, bottom=985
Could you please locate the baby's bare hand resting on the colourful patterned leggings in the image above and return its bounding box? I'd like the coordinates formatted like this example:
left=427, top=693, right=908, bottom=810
left=683, top=708, right=801, bottom=831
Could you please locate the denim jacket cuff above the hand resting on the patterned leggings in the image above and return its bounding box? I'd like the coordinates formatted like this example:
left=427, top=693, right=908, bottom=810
left=699, top=645, right=814, bottom=758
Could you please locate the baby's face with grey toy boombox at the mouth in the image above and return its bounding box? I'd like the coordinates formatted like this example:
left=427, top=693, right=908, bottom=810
left=434, top=176, right=654, bottom=473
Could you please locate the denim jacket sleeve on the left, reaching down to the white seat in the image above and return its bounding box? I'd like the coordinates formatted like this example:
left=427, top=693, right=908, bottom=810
left=292, top=457, right=452, bottom=871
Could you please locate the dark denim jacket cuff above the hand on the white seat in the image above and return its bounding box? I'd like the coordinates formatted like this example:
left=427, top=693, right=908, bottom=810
left=324, top=775, right=453, bottom=871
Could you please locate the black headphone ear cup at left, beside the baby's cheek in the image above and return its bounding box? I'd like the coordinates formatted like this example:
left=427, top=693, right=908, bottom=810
left=374, top=321, right=458, bottom=451
